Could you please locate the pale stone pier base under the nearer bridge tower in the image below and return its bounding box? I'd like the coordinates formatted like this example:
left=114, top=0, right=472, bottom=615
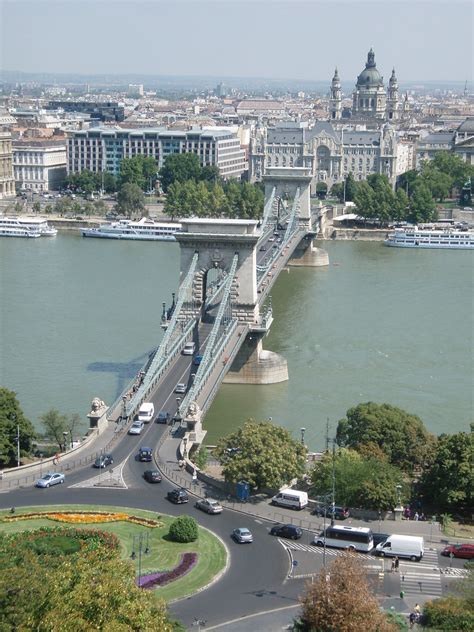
left=224, top=333, right=288, bottom=384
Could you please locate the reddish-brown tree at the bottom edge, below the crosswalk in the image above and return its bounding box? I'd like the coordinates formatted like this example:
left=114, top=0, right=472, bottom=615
left=293, top=553, right=398, bottom=632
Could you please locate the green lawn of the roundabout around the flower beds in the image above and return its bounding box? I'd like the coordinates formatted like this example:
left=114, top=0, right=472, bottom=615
left=0, top=505, right=227, bottom=601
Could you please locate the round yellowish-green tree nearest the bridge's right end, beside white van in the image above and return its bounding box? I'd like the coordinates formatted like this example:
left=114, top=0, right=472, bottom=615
left=214, top=419, right=306, bottom=489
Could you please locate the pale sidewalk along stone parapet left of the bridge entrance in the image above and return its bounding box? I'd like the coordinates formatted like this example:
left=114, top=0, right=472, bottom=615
left=0, top=422, right=126, bottom=492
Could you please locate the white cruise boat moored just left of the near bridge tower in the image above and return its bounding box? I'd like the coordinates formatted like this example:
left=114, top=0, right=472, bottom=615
left=81, top=217, right=181, bottom=241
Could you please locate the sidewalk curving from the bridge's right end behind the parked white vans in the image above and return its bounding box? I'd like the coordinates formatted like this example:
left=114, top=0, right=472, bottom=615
left=158, top=429, right=450, bottom=543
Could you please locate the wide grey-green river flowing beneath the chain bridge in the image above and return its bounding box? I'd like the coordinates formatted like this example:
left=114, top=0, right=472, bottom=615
left=0, top=232, right=474, bottom=450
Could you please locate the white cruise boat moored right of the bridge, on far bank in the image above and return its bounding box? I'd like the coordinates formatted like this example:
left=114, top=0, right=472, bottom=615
left=384, top=226, right=474, bottom=250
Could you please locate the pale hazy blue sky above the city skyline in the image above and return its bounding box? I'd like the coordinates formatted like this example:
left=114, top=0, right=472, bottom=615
left=0, top=0, right=474, bottom=82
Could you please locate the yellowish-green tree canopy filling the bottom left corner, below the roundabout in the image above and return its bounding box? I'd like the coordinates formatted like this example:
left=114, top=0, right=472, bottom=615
left=0, top=532, right=178, bottom=632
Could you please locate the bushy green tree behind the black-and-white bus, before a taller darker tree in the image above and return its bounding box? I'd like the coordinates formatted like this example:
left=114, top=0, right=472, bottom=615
left=311, top=448, right=403, bottom=511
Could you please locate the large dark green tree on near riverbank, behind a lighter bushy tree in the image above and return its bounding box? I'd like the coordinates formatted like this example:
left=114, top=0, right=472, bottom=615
left=337, top=402, right=435, bottom=472
